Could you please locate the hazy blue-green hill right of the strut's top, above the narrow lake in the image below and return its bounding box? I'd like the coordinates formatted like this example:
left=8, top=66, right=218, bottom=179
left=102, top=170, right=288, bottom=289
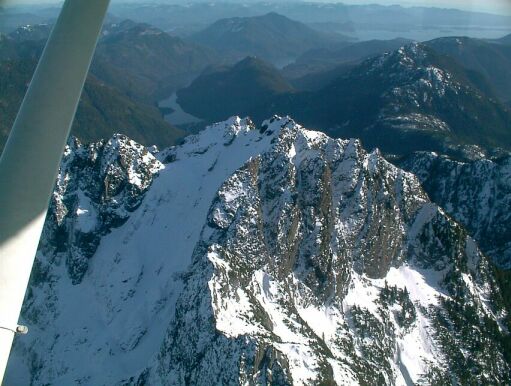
left=95, top=20, right=219, bottom=102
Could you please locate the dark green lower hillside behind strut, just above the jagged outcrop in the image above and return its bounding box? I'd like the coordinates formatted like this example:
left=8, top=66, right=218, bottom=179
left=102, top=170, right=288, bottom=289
left=0, top=59, right=184, bottom=149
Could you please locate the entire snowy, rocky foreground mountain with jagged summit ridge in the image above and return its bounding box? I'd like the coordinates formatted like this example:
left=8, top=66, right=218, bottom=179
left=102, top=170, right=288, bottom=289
left=8, top=117, right=510, bottom=385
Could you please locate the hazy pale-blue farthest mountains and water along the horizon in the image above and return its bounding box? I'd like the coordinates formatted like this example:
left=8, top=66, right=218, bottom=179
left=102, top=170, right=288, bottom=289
left=111, top=1, right=511, bottom=41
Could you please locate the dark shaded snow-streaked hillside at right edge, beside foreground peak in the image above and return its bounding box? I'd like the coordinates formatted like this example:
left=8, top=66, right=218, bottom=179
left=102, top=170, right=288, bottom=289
left=398, top=152, right=511, bottom=268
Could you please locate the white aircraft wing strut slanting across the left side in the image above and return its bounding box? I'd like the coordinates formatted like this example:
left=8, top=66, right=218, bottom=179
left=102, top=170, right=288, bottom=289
left=0, top=0, right=109, bottom=381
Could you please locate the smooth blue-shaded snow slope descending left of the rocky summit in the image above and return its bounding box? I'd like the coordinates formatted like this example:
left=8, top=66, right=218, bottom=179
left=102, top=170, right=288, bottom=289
left=6, top=118, right=278, bottom=384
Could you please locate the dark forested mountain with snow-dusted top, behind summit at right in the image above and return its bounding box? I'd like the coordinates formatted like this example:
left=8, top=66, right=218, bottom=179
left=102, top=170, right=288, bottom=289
left=180, top=43, right=511, bottom=154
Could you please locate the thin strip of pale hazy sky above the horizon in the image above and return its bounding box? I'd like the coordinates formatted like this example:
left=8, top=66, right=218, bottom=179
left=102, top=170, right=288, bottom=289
left=0, top=0, right=511, bottom=15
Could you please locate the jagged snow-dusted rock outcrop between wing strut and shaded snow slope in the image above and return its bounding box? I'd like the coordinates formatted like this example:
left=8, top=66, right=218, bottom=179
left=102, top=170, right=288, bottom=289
left=40, top=134, right=163, bottom=284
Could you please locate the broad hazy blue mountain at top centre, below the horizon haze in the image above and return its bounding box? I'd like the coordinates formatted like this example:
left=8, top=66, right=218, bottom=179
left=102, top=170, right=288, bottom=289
left=191, top=12, right=346, bottom=63
